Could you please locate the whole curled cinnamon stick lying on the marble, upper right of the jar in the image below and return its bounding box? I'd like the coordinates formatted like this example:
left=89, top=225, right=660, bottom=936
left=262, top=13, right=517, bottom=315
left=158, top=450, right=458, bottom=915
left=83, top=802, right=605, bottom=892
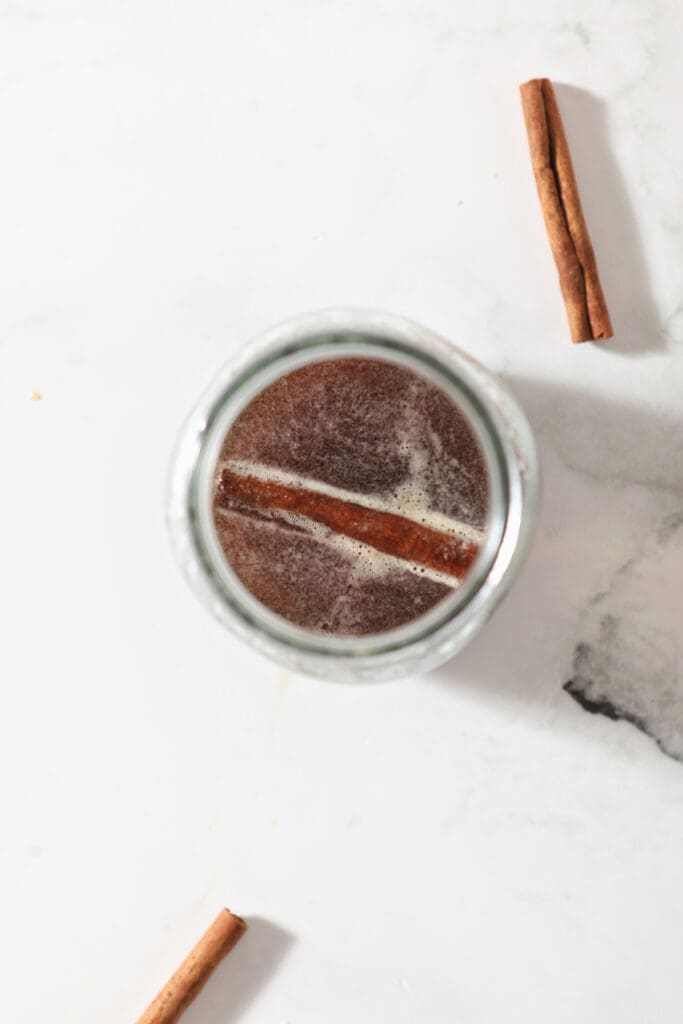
left=519, top=78, right=612, bottom=342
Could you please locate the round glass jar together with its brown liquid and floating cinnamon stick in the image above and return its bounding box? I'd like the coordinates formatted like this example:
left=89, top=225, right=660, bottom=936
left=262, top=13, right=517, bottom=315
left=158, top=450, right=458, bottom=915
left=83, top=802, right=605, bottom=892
left=169, top=310, right=539, bottom=679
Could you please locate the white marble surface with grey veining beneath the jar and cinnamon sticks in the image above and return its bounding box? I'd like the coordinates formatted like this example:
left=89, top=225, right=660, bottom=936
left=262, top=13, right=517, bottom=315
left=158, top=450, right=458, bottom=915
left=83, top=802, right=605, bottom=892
left=0, top=0, right=683, bottom=1024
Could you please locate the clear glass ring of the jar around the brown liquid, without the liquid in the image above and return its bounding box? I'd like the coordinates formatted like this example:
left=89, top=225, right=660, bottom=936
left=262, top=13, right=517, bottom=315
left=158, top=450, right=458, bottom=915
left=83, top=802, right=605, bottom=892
left=168, top=309, right=540, bottom=680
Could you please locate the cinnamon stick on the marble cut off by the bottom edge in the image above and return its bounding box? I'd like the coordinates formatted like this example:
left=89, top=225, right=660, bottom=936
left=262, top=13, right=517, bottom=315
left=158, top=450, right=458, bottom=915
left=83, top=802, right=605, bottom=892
left=137, top=909, right=247, bottom=1024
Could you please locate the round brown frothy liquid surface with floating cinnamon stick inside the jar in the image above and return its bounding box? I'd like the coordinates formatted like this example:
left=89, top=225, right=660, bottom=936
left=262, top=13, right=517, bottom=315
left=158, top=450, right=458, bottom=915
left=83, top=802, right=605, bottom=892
left=213, top=358, right=488, bottom=636
